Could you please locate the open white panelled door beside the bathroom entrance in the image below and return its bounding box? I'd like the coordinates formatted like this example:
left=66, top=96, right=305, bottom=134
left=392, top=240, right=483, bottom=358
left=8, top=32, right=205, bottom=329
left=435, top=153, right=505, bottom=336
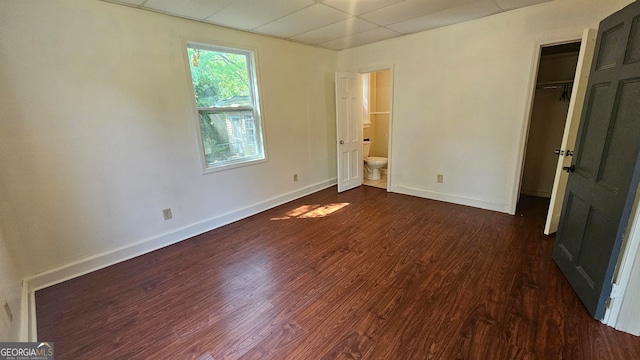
left=336, top=72, right=363, bottom=192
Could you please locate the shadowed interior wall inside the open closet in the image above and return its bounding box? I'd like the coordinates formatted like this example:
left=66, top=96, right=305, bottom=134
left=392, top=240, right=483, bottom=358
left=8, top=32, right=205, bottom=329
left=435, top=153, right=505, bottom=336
left=521, top=53, right=578, bottom=198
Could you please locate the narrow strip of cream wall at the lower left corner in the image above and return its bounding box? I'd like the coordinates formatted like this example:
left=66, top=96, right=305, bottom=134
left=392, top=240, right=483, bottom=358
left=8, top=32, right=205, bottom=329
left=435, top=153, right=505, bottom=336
left=0, top=227, right=22, bottom=342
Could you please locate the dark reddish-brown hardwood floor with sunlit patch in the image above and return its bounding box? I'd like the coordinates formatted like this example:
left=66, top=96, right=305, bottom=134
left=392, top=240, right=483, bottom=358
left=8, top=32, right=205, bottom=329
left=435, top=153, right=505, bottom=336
left=36, top=186, right=640, bottom=360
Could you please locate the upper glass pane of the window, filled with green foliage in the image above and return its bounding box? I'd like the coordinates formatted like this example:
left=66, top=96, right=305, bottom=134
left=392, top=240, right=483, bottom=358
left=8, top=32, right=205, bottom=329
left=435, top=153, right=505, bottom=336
left=187, top=47, right=251, bottom=107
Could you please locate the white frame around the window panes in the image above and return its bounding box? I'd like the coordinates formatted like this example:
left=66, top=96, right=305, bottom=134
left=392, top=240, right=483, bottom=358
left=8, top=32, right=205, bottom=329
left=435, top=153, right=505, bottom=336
left=183, top=39, right=268, bottom=174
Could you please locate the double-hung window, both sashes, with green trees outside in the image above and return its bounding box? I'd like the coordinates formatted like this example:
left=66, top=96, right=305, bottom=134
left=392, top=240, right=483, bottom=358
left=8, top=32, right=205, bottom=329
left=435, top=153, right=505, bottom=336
left=187, top=43, right=266, bottom=172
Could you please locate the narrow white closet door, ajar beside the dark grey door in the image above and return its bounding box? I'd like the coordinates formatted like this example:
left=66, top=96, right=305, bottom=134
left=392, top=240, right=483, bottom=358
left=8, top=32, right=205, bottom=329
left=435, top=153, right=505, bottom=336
left=544, top=29, right=598, bottom=235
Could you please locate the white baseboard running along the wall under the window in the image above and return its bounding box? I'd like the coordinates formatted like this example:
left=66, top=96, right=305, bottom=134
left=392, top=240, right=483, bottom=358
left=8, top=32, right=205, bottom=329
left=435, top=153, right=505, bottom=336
left=20, top=178, right=337, bottom=341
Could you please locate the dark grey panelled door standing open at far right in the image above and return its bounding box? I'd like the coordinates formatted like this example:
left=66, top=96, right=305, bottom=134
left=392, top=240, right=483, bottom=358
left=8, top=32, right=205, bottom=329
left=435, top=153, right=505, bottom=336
left=553, top=1, right=640, bottom=319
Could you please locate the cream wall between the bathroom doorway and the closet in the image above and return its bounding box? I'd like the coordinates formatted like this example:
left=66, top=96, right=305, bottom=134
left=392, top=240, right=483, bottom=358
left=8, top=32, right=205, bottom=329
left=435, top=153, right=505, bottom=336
left=338, top=0, right=631, bottom=212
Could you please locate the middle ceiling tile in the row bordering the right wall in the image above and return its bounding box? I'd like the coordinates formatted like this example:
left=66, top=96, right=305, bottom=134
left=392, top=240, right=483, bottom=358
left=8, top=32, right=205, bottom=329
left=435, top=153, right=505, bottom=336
left=387, top=0, right=502, bottom=34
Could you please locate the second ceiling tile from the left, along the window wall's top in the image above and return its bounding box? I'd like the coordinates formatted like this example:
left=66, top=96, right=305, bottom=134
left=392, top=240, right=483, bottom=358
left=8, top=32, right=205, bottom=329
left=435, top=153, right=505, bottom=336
left=142, top=0, right=233, bottom=20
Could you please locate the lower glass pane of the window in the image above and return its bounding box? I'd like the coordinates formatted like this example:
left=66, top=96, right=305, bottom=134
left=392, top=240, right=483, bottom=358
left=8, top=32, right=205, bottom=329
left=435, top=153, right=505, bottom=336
left=200, top=111, right=263, bottom=165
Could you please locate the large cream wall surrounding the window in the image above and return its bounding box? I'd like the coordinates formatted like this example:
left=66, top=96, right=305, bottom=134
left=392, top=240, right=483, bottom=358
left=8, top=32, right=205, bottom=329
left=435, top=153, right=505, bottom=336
left=0, top=0, right=337, bottom=277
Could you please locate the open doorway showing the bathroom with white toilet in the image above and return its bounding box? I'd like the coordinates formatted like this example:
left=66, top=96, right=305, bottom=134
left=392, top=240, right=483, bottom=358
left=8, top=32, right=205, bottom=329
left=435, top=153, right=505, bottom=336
left=362, top=69, right=391, bottom=189
